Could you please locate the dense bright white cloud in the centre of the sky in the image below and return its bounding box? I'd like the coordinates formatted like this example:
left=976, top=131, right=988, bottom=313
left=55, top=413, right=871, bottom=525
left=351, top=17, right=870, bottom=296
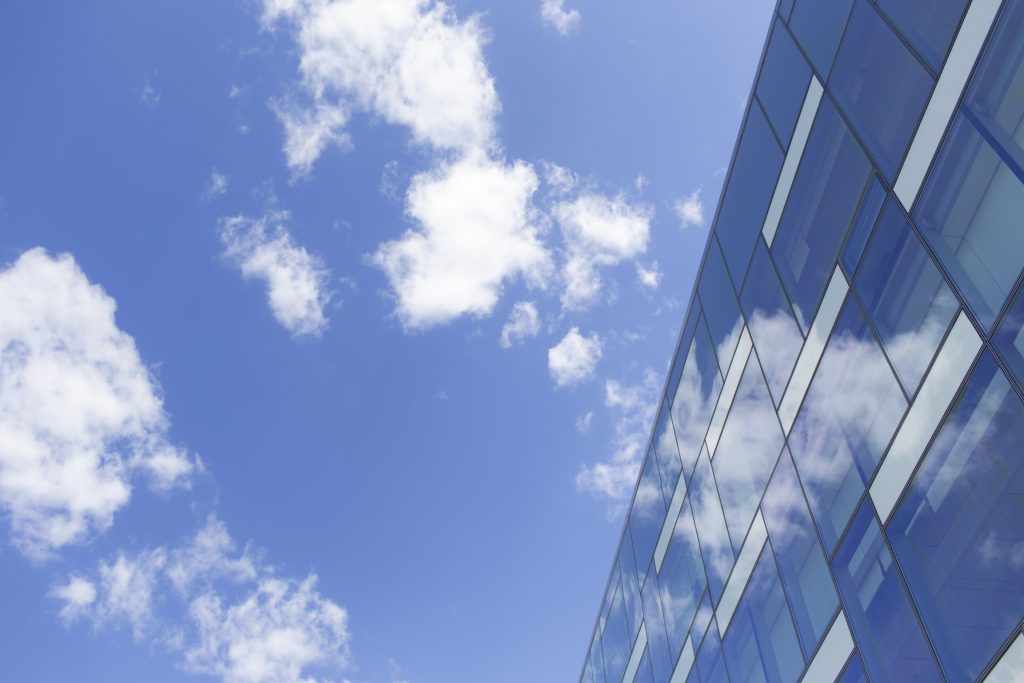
left=372, top=157, right=551, bottom=330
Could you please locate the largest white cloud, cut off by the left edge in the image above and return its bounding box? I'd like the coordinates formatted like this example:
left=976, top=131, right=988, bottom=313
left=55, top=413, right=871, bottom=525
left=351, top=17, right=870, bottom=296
left=0, top=249, right=196, bottom=557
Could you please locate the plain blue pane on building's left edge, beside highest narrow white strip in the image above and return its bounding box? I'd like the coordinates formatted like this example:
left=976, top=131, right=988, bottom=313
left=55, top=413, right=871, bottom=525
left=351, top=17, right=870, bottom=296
left=700, top=101, right=783, bottom=288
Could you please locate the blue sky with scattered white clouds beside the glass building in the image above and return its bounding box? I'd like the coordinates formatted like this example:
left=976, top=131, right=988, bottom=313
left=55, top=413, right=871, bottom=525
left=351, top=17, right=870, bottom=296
left=0, top=0, right=772, bottom=683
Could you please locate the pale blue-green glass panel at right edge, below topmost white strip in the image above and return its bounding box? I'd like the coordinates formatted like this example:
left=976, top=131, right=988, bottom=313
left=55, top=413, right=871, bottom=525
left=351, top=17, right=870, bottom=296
left=913, top=115, right=1024, bottom=330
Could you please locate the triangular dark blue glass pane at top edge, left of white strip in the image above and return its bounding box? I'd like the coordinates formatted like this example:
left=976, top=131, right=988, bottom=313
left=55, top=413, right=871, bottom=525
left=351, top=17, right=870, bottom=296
left=879, top=0, right=967, bottom=72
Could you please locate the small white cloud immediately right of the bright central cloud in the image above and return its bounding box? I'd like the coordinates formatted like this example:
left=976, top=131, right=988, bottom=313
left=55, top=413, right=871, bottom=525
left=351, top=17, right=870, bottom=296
left=552, top=194, right=652, bottom=310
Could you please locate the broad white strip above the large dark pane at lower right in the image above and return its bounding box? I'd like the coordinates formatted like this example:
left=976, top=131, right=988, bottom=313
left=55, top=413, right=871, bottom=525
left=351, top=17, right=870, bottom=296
left=871, top=311, right=981, bottom=523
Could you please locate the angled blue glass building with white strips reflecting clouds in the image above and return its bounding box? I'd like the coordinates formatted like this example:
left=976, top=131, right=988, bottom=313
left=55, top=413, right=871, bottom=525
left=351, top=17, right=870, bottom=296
left=581, top=0, right=1024, bottom=683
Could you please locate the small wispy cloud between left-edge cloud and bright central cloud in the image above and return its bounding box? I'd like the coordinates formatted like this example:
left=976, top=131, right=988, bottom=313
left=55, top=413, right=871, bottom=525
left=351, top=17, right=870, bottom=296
left=219, top=212, right=331, bottom=337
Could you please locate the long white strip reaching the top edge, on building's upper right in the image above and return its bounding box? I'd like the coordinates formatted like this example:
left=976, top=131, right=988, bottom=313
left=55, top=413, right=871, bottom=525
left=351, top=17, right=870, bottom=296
left=893, top=0, right=1001, bottom=211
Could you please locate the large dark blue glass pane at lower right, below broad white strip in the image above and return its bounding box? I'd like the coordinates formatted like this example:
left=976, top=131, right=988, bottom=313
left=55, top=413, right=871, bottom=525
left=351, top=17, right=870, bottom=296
left=888, top=355, right=1024, bottom=681
